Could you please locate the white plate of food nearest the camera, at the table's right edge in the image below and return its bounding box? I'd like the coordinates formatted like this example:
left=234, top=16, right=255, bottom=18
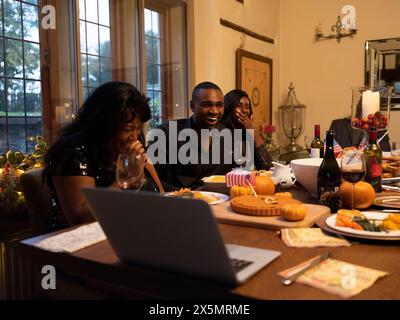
left=326, top=211, right=400, bottom=238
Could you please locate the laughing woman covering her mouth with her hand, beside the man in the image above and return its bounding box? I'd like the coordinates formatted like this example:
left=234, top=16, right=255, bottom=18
left=221, top=89, right=272, bottom=170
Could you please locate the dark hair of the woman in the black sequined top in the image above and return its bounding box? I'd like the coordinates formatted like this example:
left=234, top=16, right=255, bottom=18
left=44, top=81, right=151, bottom=165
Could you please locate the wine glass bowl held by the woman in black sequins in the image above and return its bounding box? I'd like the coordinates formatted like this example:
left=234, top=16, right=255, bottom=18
left=115, top=152, right=144, bottom=190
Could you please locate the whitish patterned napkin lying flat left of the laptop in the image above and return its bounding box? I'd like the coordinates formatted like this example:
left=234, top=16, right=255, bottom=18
left=33, top=222, right=107, bottom=253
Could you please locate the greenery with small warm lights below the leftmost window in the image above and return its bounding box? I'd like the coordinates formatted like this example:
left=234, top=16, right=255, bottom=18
left=0, top=136, right=47, bottom=220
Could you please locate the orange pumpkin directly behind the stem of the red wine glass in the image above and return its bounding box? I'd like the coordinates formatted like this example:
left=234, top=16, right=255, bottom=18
left=339, top=181, right=375, bottom=209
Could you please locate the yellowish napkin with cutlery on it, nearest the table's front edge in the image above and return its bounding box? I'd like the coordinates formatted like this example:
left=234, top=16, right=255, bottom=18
left=278, top=256, right=388, bottom=298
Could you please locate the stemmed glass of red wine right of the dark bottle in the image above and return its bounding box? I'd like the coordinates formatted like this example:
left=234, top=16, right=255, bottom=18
left=341, top=149, right=366, bottom=210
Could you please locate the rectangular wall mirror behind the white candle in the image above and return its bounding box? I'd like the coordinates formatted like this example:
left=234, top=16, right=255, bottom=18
left=365, top=38, right=400, bottom=110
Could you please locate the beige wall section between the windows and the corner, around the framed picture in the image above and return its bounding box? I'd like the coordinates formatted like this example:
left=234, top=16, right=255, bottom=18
left=188, top=0, right=279, bottom=114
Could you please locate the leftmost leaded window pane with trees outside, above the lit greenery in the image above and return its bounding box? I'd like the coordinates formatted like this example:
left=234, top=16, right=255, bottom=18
left=0, top=0, right=43, bottom=154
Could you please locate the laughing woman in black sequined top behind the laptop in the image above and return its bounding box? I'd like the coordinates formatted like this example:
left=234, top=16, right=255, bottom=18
left=44, top=81, right=163, bottom=229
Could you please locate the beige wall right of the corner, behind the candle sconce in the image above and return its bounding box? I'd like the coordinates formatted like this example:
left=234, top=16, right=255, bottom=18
left=275, top=0, right=400, bottom=143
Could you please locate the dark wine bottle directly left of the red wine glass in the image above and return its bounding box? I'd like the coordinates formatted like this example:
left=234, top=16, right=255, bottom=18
left=317, top=130, right=342, bottom=198
